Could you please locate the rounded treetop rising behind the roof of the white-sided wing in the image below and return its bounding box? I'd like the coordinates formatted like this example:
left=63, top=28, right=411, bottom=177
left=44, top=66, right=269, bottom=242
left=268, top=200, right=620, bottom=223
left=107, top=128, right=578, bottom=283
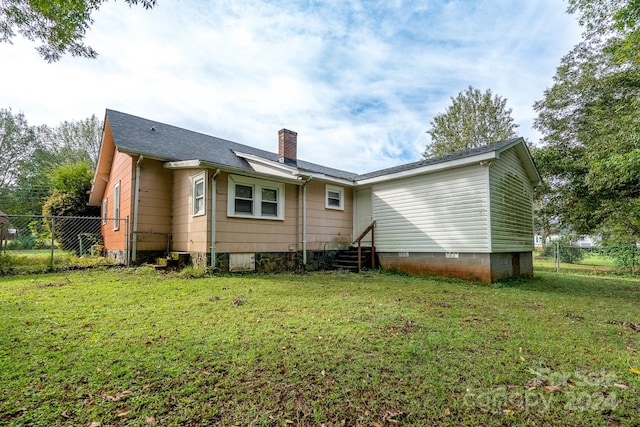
left=422, top=86, right=518, bottom=158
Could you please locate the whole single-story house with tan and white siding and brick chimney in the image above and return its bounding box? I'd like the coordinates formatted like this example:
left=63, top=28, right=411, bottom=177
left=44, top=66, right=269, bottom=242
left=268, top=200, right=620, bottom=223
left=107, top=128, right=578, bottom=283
left=89, top=110, right=540, bottom=282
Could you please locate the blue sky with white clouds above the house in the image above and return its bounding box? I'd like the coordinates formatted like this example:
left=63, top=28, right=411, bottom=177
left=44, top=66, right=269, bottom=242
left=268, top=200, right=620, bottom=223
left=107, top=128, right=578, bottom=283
left=0, top=0, right=581, bottom=172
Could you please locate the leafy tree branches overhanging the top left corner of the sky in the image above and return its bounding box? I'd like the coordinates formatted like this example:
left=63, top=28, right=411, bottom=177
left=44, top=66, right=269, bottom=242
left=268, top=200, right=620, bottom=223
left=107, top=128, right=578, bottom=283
left=0, top=0, right=156, bottom=62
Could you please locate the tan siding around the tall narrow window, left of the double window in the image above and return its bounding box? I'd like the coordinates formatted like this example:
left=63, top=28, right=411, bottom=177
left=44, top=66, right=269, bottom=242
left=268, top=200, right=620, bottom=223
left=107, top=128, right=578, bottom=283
left=172, top=169, right=211, bottom=253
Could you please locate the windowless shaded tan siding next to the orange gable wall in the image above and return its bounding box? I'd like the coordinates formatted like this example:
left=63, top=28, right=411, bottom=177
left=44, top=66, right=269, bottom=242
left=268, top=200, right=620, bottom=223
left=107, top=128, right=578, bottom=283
left=134, top=159, right=173, bottom=251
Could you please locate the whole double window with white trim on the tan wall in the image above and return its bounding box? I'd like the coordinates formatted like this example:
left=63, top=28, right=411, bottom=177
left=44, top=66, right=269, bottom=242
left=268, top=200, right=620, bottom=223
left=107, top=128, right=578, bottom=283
left=227, top=175, right=284, bottom=220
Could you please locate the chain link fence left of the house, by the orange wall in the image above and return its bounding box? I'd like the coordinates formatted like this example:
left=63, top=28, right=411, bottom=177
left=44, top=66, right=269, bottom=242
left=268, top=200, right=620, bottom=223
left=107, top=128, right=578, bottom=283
left=0, top=214, right=129, bottom=274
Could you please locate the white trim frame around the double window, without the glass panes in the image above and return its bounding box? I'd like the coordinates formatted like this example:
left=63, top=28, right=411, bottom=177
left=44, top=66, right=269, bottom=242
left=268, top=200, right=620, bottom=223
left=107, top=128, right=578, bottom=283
left=227, top=175, right=285, bottom=221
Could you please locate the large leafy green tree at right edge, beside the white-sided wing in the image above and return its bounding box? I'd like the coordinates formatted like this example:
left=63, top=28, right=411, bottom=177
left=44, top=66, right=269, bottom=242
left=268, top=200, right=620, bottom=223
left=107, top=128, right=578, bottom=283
left=534, top=0, right=640, bottom=247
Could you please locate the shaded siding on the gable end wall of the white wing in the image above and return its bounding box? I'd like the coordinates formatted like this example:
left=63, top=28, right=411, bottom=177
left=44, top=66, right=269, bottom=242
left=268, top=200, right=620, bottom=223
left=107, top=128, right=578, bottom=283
left=489, top=149, right=533, bottom=252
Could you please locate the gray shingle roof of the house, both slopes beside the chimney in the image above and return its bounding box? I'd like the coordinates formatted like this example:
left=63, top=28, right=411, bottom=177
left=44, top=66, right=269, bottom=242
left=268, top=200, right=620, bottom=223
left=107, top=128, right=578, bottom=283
left=106, top=109, right=521, bottom=181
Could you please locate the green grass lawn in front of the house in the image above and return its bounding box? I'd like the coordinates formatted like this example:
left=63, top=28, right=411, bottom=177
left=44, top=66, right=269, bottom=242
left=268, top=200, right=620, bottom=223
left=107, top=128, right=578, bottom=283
left=0, top=268, right=640, bottom=427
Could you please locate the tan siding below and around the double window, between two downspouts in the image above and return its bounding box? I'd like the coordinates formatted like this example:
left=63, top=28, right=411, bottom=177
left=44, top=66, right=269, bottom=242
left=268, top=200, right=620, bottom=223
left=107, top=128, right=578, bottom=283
left=216, top=172, right=301, bottom=253
